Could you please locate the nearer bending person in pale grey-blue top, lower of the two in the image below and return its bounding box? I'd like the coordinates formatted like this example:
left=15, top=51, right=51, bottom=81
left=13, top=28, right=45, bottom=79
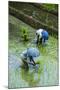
left=20, top=47, right=39, bottom=67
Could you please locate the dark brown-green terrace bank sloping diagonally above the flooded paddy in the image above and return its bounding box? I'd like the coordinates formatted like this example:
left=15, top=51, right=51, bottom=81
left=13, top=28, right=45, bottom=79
left=9, top=2, right=58, bottom=35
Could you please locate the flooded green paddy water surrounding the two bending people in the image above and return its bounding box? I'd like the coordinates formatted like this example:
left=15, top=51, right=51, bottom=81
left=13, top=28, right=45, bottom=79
left=8, top=16, right=58, bottom=88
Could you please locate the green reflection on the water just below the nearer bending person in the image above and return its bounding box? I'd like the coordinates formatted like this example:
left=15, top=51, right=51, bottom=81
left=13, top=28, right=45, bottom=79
left=21, top=69, right=40, bottom=87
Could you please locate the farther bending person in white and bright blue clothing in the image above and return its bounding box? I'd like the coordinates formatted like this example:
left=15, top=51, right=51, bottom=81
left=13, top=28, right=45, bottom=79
left=36, top=29, right=49, bottom=44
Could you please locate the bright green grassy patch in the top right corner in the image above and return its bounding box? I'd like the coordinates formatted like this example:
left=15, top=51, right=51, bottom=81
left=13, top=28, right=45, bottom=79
left=32, top=3, right=58, bottom=15
